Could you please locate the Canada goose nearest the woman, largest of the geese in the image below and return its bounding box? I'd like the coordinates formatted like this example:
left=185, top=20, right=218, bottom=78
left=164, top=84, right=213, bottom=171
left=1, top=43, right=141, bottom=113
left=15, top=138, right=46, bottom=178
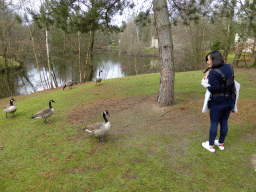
left=84, top=110, right=111, bottom=144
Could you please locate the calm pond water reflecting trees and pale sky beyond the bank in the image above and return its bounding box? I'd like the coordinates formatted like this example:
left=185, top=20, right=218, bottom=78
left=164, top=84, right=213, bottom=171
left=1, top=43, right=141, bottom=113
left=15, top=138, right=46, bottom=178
left=0, top=50, right=159, bottom=98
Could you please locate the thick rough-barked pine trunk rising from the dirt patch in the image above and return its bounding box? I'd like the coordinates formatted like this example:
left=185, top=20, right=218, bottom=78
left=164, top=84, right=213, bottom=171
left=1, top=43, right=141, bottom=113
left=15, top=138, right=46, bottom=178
left=153, top=0, right=175, bottom=107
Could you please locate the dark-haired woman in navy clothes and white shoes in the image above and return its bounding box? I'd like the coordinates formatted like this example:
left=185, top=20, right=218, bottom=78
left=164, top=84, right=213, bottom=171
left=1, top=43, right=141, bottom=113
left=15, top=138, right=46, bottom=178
left=202, top=51, right=236, bottom=152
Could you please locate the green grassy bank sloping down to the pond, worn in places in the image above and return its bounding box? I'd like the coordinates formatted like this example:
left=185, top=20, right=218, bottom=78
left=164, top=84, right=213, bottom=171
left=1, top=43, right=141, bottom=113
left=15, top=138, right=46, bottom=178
left=0, top=69, right=256, bottom=191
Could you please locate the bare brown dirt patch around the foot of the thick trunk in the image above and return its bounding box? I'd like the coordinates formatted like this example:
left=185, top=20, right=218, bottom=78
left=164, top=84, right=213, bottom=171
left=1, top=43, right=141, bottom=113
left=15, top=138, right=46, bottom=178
left=69, top=95, right=209, bottom=135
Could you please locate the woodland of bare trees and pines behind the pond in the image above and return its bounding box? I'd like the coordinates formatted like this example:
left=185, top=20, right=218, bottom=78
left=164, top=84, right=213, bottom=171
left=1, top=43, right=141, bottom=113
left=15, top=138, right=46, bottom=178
left=0, top=0, right=256, bottom=97
